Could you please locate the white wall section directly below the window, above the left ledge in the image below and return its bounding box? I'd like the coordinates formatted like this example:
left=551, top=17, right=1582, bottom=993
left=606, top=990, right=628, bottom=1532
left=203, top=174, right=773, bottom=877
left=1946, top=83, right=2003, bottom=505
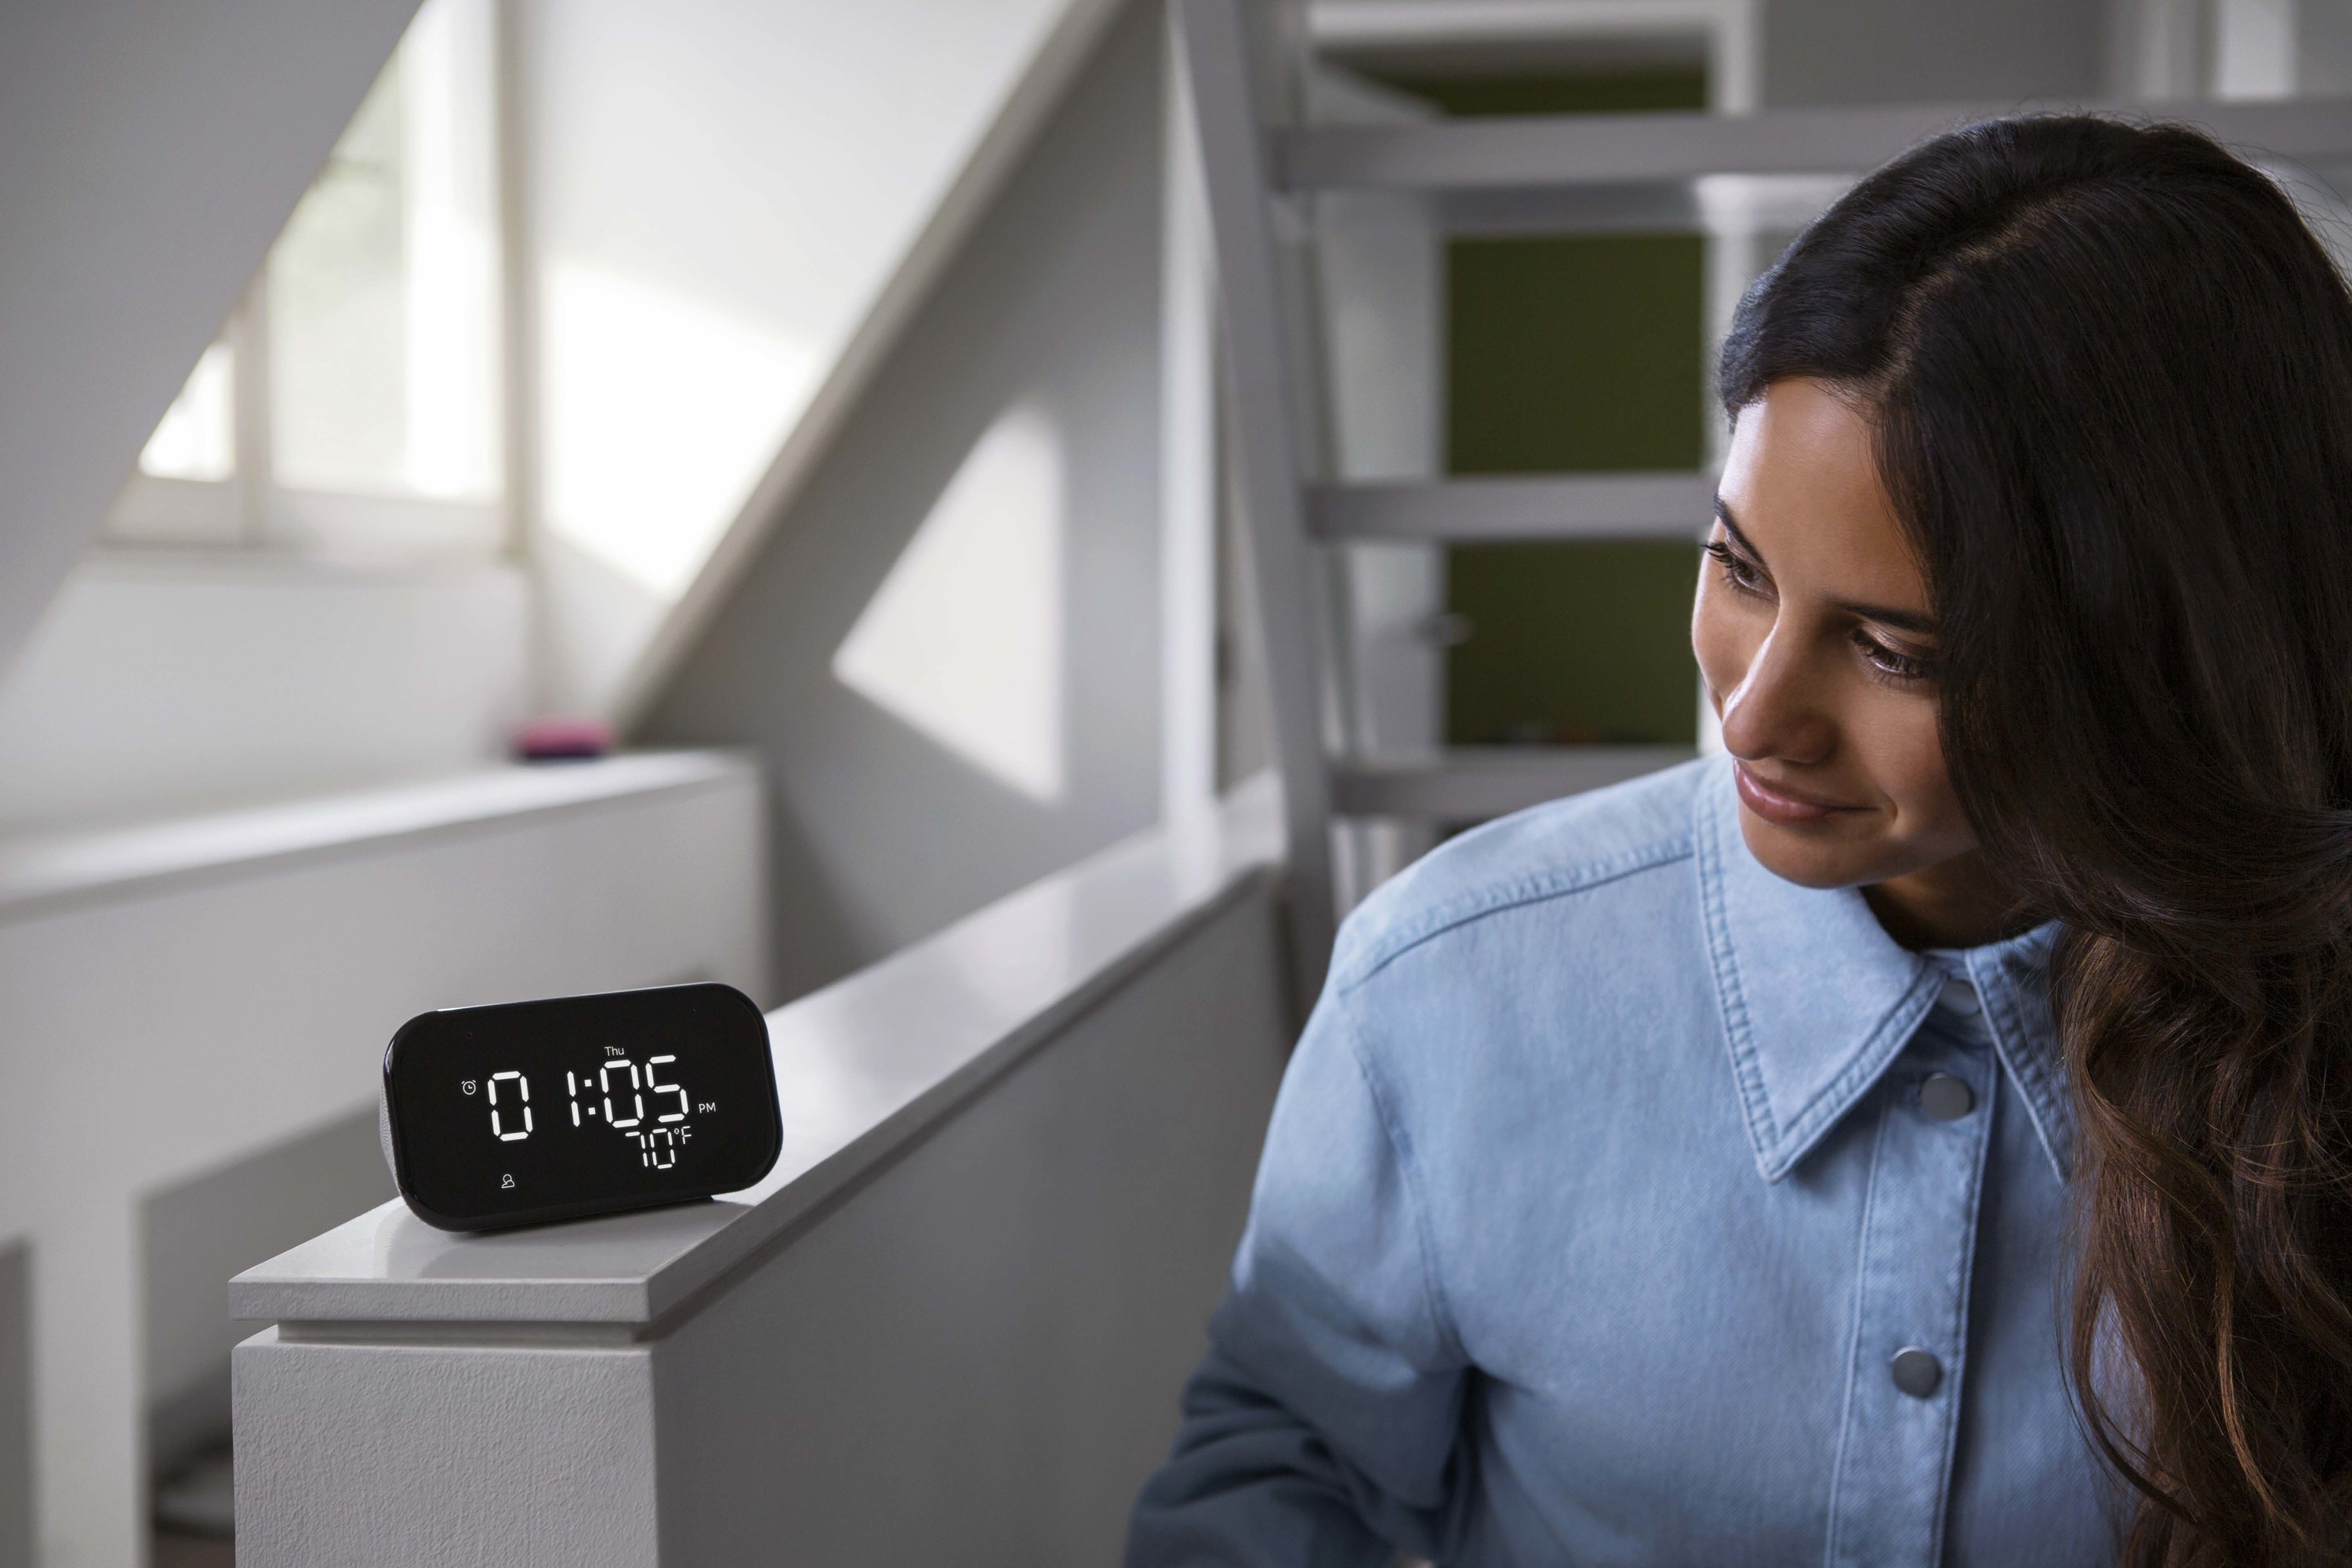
left=0, top=561, right=527, bottom=832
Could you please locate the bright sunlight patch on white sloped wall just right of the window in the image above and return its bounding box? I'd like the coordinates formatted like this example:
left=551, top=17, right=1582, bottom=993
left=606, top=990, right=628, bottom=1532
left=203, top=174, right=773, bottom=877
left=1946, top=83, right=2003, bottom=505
left=543, top=261, right=816, bottom=600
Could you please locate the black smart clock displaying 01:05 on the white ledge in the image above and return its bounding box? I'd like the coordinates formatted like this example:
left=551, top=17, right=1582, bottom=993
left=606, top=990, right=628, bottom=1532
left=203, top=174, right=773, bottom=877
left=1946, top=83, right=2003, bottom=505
left=381, top=985, right=783, bottom=1229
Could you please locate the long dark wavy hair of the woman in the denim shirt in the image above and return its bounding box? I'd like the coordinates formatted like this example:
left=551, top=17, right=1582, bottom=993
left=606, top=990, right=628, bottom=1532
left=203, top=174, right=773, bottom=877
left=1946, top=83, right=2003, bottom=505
left=1719, top=115, right=2352, bottom=1568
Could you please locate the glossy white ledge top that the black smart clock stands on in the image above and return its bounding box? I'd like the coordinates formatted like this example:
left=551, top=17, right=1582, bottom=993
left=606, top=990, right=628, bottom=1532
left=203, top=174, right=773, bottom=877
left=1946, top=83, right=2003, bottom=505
left=228, top=781, right=1279, bottom=1338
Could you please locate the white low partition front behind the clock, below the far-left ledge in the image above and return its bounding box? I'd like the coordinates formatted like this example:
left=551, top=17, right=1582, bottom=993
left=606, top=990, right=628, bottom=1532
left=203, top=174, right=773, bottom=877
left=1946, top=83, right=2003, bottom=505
left=0, top=767, right=767, bottom=1568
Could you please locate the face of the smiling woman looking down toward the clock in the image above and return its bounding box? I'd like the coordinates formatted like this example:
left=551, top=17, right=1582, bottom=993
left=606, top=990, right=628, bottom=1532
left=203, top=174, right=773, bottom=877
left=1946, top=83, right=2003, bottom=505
left=1691, top=381, right=1976, bottom=893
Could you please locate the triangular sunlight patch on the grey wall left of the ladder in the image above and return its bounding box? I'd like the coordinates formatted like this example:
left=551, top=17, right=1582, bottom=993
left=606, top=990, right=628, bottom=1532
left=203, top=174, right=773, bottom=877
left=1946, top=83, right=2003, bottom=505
left=833, top=407, right=1065, bottom=801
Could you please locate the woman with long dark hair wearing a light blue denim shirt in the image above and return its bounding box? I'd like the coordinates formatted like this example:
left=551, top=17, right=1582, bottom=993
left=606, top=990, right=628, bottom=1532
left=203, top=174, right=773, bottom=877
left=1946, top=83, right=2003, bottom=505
left=1129, top=118, right=2352, bottom=1568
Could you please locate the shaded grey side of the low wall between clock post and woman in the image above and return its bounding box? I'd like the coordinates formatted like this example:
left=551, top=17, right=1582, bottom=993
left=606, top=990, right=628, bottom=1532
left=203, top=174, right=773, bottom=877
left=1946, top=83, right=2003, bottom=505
left=654, top=888, right=1289, bottom=1568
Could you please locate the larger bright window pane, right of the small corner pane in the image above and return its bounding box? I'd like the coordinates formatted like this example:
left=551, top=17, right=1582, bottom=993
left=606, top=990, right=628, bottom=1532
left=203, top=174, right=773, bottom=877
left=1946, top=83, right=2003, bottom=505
left=268, top=0, right=499, bottom=499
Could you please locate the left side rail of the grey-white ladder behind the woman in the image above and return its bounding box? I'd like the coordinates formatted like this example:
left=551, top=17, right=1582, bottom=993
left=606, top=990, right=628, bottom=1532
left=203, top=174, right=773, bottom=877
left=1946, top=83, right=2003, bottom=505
left=1171, top=0, right=1336, bottom=994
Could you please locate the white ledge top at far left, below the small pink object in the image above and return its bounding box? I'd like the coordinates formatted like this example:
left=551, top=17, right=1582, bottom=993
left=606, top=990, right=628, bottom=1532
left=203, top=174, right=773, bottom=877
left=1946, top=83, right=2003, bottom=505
left=0, top=753, right=755, bottom=921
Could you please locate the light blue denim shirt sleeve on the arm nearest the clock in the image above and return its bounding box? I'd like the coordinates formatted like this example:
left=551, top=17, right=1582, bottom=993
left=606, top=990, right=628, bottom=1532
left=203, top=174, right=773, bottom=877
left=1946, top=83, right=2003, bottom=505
left=1127, top=973, right=1465, bottom=1568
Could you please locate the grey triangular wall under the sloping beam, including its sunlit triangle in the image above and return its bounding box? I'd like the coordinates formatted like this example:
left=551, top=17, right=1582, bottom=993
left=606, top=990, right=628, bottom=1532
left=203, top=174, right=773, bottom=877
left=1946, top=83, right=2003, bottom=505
left=644, top=0, right=1162, bottom=996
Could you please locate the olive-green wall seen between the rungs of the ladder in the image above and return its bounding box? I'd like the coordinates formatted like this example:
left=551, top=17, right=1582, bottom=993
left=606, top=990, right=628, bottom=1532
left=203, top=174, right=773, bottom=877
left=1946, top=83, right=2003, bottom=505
left=1390, top=68, right=1708, bottom=746
